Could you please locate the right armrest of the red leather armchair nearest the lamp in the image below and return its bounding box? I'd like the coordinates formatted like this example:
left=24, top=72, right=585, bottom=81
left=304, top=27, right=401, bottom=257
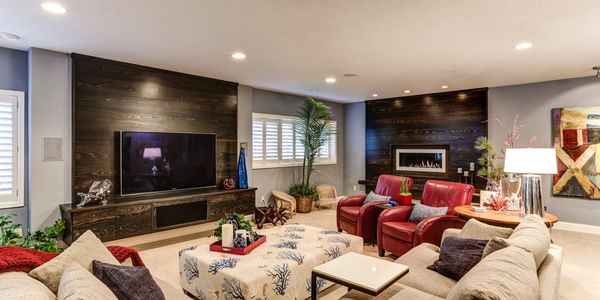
left=413, top=215, right=467, bottom=247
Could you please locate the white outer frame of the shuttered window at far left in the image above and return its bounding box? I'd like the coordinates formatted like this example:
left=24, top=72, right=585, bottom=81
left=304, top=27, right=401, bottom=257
left=0, top=90, right=25, bottom=209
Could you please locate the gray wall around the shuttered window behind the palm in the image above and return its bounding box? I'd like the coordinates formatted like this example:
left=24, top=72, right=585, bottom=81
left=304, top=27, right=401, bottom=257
left=243, top=87, right=345, bottom=204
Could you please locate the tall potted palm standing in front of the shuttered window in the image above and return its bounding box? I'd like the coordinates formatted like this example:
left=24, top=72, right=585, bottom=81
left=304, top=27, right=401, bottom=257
left=288, top=98, right=334, bottom=213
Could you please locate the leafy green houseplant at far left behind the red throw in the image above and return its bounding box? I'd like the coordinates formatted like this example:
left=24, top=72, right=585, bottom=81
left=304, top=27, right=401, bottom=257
left=0, top=214, right=65, bottom=252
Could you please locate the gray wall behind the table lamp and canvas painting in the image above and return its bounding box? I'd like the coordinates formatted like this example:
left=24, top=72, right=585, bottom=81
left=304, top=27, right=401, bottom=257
left=488, top=78, right=600, bottom=225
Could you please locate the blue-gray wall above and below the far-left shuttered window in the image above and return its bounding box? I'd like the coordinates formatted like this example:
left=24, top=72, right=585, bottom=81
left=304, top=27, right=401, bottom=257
left=0, top=47, right=29, bottom=229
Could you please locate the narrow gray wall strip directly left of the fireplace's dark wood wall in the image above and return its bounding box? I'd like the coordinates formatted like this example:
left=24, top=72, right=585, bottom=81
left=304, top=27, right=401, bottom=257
left=344, top=102, right=366, bottom=195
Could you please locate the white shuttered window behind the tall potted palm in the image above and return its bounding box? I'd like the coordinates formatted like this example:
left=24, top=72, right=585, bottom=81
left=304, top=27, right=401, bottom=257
left=252, top=113, right=337, bottom=169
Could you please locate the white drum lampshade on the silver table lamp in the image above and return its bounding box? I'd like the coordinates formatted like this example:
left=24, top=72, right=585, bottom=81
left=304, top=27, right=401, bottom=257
left=504, top=148, right=558, bottom=174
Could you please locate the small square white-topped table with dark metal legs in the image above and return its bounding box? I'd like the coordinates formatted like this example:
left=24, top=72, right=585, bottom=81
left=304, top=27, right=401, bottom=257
left=310, top=252, right=408, bottom=299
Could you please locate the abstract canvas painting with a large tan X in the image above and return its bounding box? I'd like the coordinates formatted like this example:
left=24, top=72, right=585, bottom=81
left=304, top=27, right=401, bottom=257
left=552, top=106, right=600, bottom=199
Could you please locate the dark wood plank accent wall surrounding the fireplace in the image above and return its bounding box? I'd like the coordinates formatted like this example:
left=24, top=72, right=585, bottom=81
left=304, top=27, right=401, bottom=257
left=365, top=88, right=487, bottom=199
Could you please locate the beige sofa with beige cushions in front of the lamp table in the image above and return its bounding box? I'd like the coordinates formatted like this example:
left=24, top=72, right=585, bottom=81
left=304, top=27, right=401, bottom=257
left=342, top=216, right=563, bottom=300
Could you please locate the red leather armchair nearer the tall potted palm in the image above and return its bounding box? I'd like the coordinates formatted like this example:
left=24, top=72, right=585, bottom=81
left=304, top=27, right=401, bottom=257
left=336, top=174, right=413, bottom=242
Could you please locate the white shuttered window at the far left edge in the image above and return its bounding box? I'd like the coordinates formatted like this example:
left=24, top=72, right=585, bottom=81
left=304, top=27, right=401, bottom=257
left=0, top=90, right=25, bottom=208
